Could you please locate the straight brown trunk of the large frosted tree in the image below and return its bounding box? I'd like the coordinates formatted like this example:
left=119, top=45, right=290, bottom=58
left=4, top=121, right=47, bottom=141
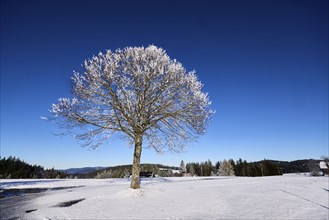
left=130, top=136, right=143, bottom=189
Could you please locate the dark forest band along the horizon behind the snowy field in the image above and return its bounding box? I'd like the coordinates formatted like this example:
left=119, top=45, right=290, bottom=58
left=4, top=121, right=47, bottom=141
left=0, top=156, right=319, bottom=179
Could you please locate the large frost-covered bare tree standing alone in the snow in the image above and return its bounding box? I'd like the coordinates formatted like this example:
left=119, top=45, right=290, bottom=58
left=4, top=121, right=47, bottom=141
left=48, top=45, right=214, bottom=189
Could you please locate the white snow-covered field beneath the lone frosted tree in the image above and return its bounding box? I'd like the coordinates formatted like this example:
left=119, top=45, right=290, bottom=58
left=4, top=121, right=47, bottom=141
left=0, top=175, right=329, bottom=220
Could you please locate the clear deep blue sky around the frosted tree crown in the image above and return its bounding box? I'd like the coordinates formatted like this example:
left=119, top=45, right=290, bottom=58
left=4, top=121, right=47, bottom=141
left=1, top=0, right=328, bottom=168
